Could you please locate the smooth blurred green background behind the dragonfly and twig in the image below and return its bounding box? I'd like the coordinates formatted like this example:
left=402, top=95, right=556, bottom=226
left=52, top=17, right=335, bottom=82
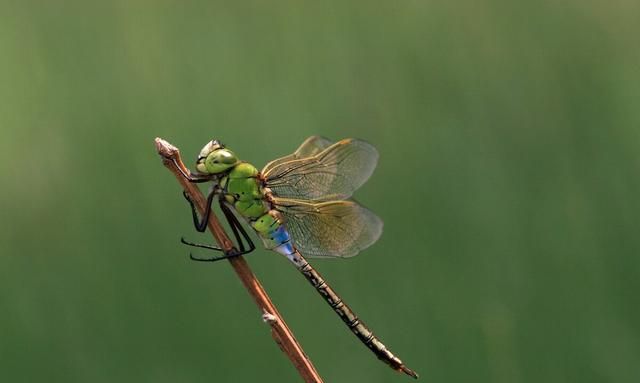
left=0, top=0, right=640, bottom=382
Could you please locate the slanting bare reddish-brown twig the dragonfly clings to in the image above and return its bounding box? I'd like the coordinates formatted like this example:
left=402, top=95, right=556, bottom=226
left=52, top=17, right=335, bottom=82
left=155, top=138, right=322, bottom=383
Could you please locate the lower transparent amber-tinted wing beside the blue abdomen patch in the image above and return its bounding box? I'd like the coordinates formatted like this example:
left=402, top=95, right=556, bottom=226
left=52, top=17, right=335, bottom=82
left=274, top=198, right=383, bottom=257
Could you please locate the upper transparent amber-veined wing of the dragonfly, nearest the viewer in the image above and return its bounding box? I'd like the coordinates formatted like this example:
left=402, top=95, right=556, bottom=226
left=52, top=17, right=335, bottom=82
left=262, top=139, right=378, bottom=201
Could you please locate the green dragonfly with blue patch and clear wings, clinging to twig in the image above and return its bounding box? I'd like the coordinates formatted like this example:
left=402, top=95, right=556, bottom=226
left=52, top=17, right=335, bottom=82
left=178, top=136, right=418, bottom=379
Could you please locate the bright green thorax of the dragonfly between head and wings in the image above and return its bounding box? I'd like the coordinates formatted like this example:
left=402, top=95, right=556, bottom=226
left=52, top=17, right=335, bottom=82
left=220, top=162, right=269, bottom=221
